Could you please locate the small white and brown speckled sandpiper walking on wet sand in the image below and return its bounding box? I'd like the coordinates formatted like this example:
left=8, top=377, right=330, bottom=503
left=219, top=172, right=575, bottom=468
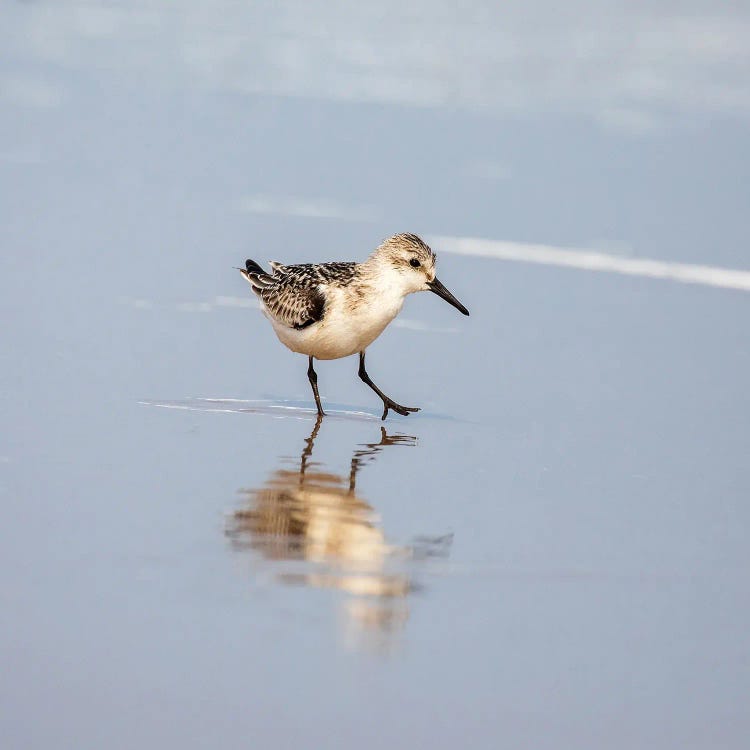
left=237, top=232, right=469, bottom=420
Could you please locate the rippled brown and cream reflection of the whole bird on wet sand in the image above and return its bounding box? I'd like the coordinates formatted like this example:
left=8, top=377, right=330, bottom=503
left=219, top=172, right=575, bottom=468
left=227, top=416, right=452, bottom=651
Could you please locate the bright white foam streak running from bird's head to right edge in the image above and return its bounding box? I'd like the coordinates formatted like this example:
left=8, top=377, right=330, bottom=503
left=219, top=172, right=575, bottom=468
left=430, top=236, right=750, bottom=292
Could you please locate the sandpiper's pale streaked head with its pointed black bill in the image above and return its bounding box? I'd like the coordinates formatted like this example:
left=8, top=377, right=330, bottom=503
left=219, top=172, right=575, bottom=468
left=369, top=233, right=469, bottom=315
